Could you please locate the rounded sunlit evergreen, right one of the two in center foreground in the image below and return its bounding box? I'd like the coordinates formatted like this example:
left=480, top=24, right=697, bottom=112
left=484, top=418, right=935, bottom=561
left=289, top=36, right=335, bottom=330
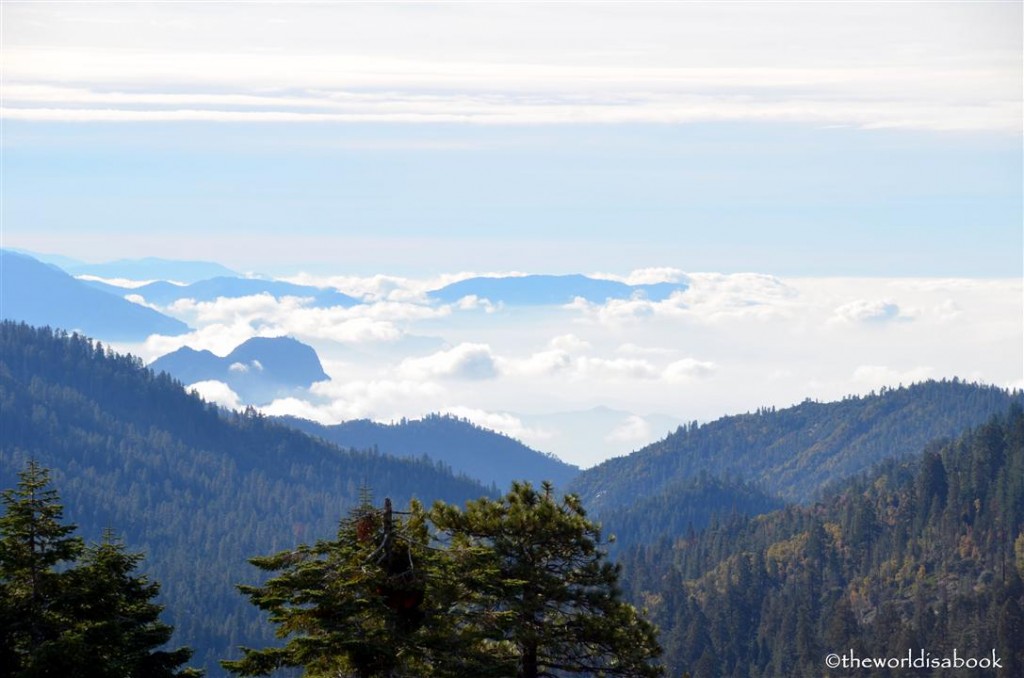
left=432, top=483, right=662, bottom=678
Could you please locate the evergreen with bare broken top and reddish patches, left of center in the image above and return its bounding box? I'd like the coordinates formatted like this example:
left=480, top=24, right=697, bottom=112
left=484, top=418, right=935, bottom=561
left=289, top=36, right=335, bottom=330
left=221, top=496, right=475, bottom=678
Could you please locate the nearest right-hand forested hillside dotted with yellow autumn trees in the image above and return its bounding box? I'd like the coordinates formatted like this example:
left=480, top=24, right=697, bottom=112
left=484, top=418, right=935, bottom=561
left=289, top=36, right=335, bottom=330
left=621, top=405, right=1024, bottom=678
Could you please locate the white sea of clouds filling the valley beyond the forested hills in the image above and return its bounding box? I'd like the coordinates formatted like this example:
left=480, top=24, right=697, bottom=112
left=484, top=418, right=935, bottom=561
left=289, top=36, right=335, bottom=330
left=112, top=270, right=1024, bottom=466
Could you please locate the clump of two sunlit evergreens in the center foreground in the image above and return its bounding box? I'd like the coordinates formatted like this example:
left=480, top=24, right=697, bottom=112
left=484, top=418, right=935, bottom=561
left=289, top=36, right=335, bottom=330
left=221, top=484, right=662, bottom=678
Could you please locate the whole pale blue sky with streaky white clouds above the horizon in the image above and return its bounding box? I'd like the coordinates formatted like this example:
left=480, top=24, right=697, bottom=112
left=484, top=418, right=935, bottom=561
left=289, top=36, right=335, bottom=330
left=3, top=2, right=1022, bottom=277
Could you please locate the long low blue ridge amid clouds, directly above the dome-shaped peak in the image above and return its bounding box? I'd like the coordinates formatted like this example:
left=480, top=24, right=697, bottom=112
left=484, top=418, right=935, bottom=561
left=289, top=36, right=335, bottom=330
left=84, top=277, right=359, bottom=307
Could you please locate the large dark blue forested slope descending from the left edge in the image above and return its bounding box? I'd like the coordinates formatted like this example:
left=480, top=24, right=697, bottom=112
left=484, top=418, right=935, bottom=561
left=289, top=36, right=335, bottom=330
left=0, top=322, right=489, bottom=676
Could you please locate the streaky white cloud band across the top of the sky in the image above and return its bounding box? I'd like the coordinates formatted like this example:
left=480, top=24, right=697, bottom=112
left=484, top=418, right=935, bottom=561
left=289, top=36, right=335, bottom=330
left=4, top=3, right=1021, bottom=133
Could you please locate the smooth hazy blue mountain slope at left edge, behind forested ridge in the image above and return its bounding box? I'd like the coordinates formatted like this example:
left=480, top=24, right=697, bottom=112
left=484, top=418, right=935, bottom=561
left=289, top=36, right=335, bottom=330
left=0, top=250, right=188, bottom=341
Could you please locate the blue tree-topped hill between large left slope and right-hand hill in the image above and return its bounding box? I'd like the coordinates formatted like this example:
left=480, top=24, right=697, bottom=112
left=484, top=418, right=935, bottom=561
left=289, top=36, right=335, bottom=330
left=282, top=415, right=580, bottom=489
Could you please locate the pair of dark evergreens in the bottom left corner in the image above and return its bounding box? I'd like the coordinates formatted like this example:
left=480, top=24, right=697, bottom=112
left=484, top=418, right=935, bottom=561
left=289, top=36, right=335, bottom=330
left=0, top=462, right=200, bottom=678
